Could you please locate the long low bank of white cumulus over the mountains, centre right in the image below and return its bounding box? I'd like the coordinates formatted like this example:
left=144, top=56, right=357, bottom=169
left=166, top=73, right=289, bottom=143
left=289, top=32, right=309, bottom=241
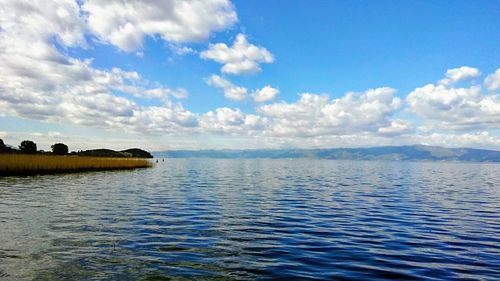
left=195, top=87, right=413, bottom=141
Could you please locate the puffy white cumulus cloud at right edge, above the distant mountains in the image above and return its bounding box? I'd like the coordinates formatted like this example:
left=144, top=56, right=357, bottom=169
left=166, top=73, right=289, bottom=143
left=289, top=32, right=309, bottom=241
left=406, top=68, right=500, bottom=130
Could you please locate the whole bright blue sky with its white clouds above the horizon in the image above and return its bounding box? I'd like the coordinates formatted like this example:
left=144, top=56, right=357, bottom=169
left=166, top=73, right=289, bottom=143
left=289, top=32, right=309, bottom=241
left=0, top=0, right=500, bottom=151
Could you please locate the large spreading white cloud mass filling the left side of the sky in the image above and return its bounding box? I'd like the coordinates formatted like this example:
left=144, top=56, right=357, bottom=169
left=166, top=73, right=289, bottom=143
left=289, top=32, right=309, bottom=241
left=0, top=0, right=201, bottom=132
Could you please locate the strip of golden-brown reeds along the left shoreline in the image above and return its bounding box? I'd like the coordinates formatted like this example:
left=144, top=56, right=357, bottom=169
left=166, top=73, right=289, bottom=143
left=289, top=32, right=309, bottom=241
left=0, top=154, right=152, bottom=176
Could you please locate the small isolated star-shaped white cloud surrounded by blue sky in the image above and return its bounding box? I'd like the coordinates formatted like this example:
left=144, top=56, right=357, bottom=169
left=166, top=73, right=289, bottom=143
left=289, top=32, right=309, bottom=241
left=200, top=33, right=274, bottom=75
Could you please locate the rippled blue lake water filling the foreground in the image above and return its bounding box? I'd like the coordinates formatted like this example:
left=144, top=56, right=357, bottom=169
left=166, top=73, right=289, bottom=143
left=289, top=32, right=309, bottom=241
left=0, top=159, right=500, bottom=280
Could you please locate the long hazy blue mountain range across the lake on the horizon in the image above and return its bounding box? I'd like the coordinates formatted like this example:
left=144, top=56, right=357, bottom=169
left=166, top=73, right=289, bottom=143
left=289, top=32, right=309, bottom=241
left=153, top=145, right=500, bottom=162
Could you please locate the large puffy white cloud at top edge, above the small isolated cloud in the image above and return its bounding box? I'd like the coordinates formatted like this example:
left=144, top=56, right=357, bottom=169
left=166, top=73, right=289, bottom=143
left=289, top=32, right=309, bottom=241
left=82, top=0, right=238, bottom=52
